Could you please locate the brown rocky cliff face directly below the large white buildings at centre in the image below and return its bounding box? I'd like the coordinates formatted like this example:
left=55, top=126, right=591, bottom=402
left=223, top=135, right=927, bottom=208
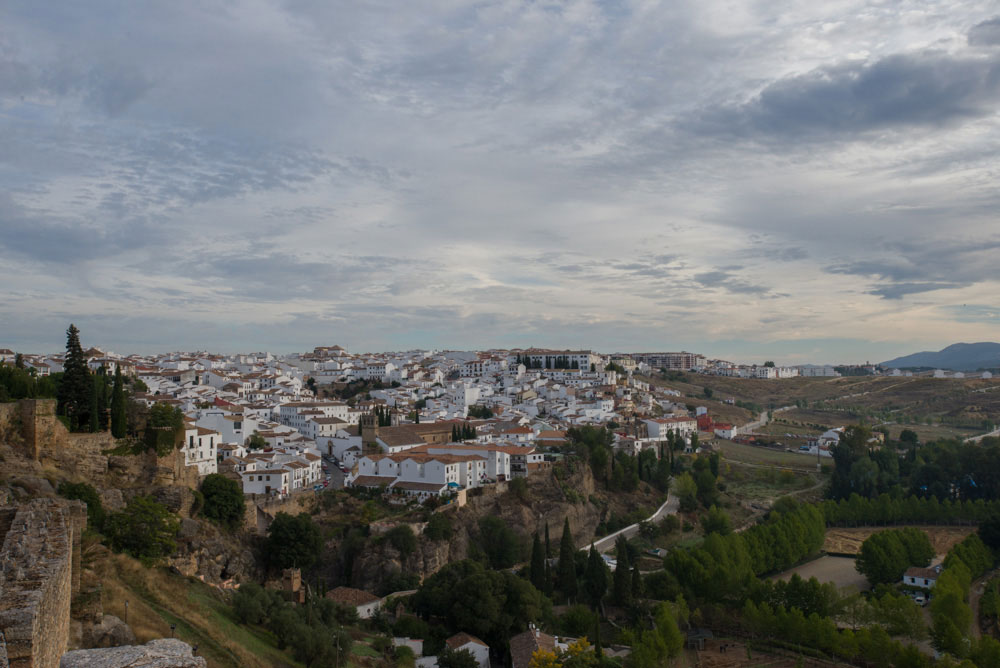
left=350, top=467, right=601, bottom=591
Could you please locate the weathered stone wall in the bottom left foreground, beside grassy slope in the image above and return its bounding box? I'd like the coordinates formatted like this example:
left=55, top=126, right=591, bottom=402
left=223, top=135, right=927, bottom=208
left=0, top=499, right=87, bottom=668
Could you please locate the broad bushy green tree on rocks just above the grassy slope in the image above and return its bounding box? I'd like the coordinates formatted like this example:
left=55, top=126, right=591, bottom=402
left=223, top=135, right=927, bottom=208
left=104, top=496, right=180, bottom=560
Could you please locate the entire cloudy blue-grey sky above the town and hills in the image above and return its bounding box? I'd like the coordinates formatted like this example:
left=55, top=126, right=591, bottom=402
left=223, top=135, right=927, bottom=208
left=0, top=0, right=1000, bottom=364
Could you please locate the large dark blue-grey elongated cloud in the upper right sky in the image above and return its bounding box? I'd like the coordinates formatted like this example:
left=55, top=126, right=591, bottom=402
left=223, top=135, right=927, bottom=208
left=690, top=52, right=1000, bottom=141
